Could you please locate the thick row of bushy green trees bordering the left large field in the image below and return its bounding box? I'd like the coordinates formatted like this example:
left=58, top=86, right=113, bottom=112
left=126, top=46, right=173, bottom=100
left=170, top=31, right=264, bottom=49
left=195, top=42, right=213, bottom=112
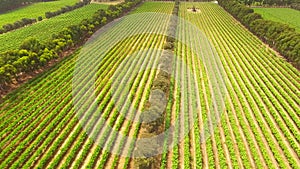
left=0, top=0, right=141, bottom=89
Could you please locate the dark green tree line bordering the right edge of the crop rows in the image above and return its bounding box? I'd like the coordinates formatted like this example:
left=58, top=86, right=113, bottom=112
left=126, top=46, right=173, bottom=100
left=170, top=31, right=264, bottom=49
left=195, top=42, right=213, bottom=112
left=219, top=0, right=300, bottom=69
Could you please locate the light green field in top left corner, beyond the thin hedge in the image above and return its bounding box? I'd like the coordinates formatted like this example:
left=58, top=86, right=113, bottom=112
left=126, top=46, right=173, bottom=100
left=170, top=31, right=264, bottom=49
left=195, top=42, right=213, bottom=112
left=0, top=0, right=79, bottom=27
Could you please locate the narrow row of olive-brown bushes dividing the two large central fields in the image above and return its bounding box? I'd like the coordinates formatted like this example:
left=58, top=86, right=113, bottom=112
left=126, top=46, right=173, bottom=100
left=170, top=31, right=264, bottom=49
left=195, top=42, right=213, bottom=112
left=134, top=0, right=179, bottom=169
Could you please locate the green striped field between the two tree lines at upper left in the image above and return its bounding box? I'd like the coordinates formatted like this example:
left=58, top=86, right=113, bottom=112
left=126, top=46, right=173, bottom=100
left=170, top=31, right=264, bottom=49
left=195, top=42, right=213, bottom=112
left=0, top=4, right=108, bottom=52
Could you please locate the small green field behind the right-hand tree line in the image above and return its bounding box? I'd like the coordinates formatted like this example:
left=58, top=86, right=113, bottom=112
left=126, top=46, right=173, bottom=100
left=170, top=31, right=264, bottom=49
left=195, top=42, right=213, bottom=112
left=253, top=8, right=300, bottom=32
